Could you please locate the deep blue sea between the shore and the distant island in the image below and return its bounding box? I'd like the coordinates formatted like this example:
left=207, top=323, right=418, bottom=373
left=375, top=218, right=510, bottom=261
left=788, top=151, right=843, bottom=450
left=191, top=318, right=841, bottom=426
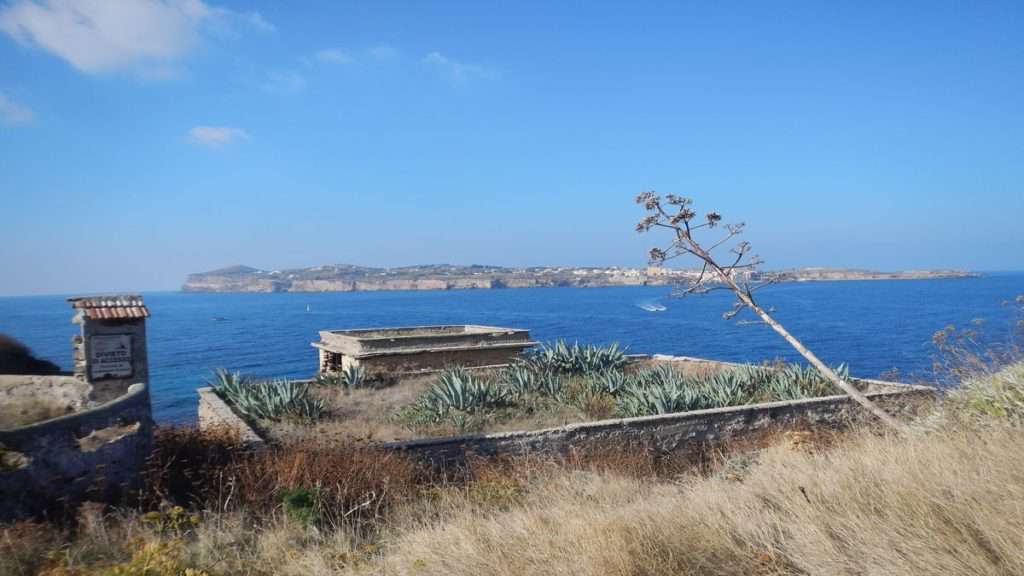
left=0, top=273, right=1024, bottom=422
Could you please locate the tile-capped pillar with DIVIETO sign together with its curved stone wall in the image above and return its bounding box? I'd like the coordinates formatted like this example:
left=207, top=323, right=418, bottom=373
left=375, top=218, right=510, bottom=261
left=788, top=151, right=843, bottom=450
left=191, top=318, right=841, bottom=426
left=0, top=295, right=153, bottom=520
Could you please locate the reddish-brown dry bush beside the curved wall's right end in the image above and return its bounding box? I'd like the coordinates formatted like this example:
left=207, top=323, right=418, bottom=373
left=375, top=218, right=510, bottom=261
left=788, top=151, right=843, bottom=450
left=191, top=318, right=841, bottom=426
left=141, top=427, right=425, bottom=523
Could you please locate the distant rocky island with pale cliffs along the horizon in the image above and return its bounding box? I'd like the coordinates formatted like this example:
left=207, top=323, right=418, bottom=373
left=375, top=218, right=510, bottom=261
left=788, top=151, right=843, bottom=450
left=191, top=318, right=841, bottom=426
left=181, top=264, right=978, bottom=292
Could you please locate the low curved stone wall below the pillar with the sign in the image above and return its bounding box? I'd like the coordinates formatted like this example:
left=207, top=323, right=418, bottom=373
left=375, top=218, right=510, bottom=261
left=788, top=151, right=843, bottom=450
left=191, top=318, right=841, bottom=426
left=0, top=383, right=153, bottom=520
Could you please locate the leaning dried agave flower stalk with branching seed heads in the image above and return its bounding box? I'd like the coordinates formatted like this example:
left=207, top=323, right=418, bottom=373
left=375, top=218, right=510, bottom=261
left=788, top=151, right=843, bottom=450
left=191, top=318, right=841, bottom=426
left=636, top=192, right=901, bottom=428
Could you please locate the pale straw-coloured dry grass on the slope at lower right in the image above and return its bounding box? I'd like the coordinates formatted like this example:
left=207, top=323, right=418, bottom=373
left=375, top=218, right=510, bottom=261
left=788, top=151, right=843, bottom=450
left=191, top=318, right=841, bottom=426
left=378, top=420, right=1024, bottom=575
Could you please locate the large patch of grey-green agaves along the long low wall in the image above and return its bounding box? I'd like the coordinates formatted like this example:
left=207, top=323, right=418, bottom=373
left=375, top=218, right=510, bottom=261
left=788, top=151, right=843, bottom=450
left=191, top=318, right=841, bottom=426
left=392, top=341, right=848, bottom=435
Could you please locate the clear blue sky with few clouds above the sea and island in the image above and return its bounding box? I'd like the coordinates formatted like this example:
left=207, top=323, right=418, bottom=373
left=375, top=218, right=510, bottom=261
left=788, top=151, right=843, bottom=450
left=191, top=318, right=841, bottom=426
left=0, top=0, right=1024, bottom=294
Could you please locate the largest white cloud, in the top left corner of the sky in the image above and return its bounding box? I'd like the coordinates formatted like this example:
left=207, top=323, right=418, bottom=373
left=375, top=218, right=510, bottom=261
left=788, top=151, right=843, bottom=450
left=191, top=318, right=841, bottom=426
left=0, top=0, right=273, bottom=74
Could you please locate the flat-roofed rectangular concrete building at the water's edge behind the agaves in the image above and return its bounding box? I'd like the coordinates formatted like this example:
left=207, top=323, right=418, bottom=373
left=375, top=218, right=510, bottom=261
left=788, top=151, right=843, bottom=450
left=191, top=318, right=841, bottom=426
left=312, top=325, right=537, bottom=375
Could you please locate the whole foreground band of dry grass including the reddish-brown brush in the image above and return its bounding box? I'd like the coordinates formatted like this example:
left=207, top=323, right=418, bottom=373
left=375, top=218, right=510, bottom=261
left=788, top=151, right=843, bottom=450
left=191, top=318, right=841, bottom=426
left=9, top=366, right=1024, bottom=576
